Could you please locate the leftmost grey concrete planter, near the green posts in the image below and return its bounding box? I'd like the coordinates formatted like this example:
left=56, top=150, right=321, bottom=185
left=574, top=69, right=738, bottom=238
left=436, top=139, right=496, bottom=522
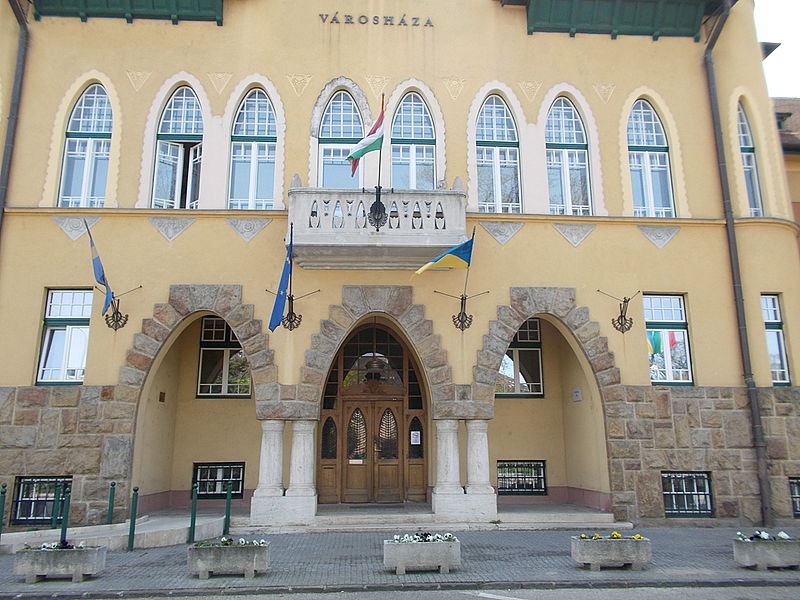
left=14, top=546, right=107, bottom=583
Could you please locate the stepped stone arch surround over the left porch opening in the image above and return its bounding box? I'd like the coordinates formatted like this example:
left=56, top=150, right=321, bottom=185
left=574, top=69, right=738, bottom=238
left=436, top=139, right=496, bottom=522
left=119, top=285, right=277, bottom=400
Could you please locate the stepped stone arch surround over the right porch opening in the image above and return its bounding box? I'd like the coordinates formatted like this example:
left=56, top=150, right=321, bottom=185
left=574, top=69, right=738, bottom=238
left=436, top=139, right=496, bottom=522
left=472, top=287, right=620, bottom=403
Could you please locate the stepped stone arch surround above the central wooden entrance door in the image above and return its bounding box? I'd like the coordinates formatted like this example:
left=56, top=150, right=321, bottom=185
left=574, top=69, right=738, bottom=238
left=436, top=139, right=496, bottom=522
left=256, top=285, right=455, bottom=419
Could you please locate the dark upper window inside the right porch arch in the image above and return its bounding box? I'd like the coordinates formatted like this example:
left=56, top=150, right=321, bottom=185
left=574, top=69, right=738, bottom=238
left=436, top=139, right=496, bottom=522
left=495, top=319, right=544, bottom=398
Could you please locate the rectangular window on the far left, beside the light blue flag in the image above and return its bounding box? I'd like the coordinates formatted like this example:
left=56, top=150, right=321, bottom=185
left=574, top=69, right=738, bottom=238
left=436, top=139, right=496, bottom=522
left=37, top=290, right=92, bottom=383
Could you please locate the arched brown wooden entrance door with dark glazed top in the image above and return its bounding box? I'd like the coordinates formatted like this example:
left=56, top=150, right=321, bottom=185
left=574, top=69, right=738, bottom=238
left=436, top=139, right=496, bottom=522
left=317, top=322, right=427, bottom=503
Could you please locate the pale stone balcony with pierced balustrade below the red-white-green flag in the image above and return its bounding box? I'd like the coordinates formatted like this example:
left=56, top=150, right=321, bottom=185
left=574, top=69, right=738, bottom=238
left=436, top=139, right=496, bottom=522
left=289, top=188, right=467, bottom=269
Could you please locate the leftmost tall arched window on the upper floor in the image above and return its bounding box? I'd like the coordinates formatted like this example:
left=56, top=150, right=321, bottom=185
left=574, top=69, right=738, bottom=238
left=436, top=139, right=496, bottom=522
left=58, top=83, right=112, bottom=208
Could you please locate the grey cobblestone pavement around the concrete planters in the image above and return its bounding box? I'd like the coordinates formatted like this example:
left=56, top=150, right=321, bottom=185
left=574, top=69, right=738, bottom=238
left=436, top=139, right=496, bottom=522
left=0, top=528, right=800, bottom=598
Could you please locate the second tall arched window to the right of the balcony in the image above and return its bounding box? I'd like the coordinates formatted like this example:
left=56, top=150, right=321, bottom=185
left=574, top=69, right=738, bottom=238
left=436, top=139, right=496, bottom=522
left=545, top=97, right=592, bottom=215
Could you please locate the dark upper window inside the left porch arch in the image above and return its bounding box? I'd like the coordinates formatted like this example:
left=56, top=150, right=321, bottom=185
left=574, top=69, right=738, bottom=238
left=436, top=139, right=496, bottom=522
left=197, top=317, right=250, bottom=397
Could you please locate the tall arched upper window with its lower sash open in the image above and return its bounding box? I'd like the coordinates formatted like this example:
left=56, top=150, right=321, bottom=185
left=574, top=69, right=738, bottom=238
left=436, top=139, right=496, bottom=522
left=153, top=86, right=203, bottom=208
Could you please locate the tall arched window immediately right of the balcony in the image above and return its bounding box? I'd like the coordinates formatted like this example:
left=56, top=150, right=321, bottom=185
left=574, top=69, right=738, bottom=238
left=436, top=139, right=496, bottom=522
left=476, top=94, right=522, bottom=214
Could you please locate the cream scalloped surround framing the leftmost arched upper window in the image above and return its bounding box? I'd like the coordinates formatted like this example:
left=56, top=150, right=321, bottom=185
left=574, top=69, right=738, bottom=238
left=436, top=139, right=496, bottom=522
left=39, top=71, right=123, bottom=208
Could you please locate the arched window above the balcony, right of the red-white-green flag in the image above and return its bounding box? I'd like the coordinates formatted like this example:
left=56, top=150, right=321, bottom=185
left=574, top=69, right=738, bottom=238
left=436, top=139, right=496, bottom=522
left=392, top=92, right=436, bottom=190
